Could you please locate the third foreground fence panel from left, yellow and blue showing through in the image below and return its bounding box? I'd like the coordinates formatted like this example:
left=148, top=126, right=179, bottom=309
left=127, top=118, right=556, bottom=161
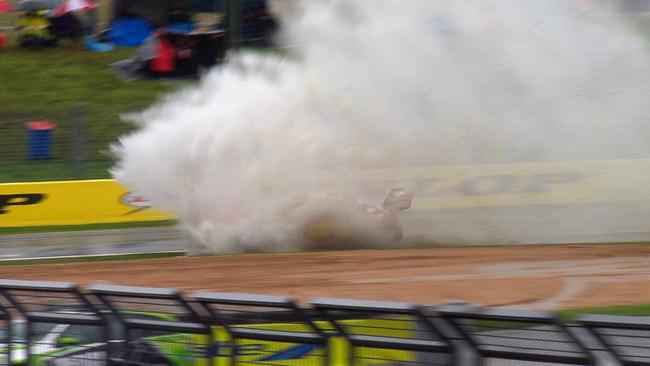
left=192, top=292, right=330, bottom=366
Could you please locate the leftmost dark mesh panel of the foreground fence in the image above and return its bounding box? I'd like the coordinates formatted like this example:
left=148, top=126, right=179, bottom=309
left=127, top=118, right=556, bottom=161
left=0, top=280, right=110, bottom=365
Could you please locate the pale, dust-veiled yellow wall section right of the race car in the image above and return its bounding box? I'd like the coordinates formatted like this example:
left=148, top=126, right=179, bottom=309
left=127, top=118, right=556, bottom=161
left=352, top=159, right=650, bottom=211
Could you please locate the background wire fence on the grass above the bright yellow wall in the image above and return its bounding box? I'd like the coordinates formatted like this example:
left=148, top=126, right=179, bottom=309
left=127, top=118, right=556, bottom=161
left=0, top=105, right=142, bottom=183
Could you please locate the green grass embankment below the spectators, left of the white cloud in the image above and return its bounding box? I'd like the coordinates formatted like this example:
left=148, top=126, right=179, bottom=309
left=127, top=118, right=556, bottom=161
left=0, top=36, right=188, bottom=183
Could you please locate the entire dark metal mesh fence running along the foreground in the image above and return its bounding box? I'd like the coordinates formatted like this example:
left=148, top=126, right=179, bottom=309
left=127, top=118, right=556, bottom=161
left=0, top=280, right=650, bottom=366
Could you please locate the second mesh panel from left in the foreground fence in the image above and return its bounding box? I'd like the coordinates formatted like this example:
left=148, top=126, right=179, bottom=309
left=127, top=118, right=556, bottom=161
left=88, top=285, right=212, bottom=365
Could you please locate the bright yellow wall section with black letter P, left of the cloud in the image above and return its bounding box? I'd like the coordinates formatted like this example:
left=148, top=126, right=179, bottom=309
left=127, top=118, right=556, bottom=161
left=0, top=179, right=173, bottom=227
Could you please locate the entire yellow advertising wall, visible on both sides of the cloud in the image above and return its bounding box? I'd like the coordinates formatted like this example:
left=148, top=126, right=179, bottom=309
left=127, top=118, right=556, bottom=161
left=0, top=159, right=650, bottom=227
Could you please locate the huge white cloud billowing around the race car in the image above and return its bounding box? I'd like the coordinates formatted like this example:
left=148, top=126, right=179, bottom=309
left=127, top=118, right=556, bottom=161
left=113, top=0, right=650, bottom=251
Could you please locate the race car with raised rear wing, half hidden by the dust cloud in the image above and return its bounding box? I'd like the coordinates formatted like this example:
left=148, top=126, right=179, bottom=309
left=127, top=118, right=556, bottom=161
left=294, top=188, right=412, bottom=249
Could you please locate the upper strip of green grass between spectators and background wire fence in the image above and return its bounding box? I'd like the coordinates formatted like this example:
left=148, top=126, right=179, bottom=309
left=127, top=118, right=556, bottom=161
left=0, top=46, right=165, bottom=110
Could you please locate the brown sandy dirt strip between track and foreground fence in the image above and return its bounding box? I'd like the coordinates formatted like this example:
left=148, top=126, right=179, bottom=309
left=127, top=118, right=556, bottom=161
left=0, top=245, right=650, bottom=309
